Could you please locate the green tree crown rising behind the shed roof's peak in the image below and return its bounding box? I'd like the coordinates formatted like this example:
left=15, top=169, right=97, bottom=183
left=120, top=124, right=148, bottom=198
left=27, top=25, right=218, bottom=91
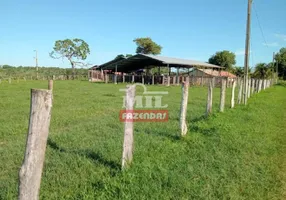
left=133, top=37, right=162, bottom=55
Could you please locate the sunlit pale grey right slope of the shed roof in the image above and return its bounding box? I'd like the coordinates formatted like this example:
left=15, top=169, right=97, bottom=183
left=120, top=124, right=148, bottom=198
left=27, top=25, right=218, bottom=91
left=141, top=54, right=224, bottom=68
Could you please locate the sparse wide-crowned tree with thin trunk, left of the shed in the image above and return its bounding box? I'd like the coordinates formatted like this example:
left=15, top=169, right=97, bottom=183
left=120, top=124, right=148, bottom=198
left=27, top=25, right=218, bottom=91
left=50, top=38, right=90, bottom=78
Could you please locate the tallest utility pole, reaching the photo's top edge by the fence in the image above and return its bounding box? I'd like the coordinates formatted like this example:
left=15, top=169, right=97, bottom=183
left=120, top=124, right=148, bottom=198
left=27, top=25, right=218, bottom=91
left=243, top=0, right=252, bottom=105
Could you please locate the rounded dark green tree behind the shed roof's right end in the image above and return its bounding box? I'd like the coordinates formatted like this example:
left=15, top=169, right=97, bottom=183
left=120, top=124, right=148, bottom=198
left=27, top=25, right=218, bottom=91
left=209, top=50, right=236, bottom=71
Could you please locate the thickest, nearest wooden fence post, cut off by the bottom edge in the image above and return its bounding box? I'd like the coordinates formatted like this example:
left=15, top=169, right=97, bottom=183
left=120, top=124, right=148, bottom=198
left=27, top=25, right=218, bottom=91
left=18, top=89, right=52, bottom=200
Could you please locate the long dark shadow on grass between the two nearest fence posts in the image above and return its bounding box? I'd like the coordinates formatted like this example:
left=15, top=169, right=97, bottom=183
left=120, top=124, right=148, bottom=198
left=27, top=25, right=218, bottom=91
left=47, top=138, right=121, bottom=171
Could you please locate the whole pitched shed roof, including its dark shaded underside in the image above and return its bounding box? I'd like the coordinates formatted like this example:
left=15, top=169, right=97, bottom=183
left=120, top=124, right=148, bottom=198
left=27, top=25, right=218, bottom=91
left=99, top=54, right=223, bottom=72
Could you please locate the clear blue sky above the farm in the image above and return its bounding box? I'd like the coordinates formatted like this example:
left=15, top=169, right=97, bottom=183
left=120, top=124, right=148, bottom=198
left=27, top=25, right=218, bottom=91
left=0, top=0, right=286, bottom=67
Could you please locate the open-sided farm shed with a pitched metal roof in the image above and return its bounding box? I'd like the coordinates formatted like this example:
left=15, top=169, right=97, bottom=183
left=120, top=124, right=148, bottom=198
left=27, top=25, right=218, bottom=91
left=89, top=54, right=230, bottom=84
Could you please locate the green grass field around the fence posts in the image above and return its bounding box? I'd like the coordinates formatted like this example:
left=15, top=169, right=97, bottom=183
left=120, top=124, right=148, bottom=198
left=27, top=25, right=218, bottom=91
left=0, top=81, right=286, bottom=199
